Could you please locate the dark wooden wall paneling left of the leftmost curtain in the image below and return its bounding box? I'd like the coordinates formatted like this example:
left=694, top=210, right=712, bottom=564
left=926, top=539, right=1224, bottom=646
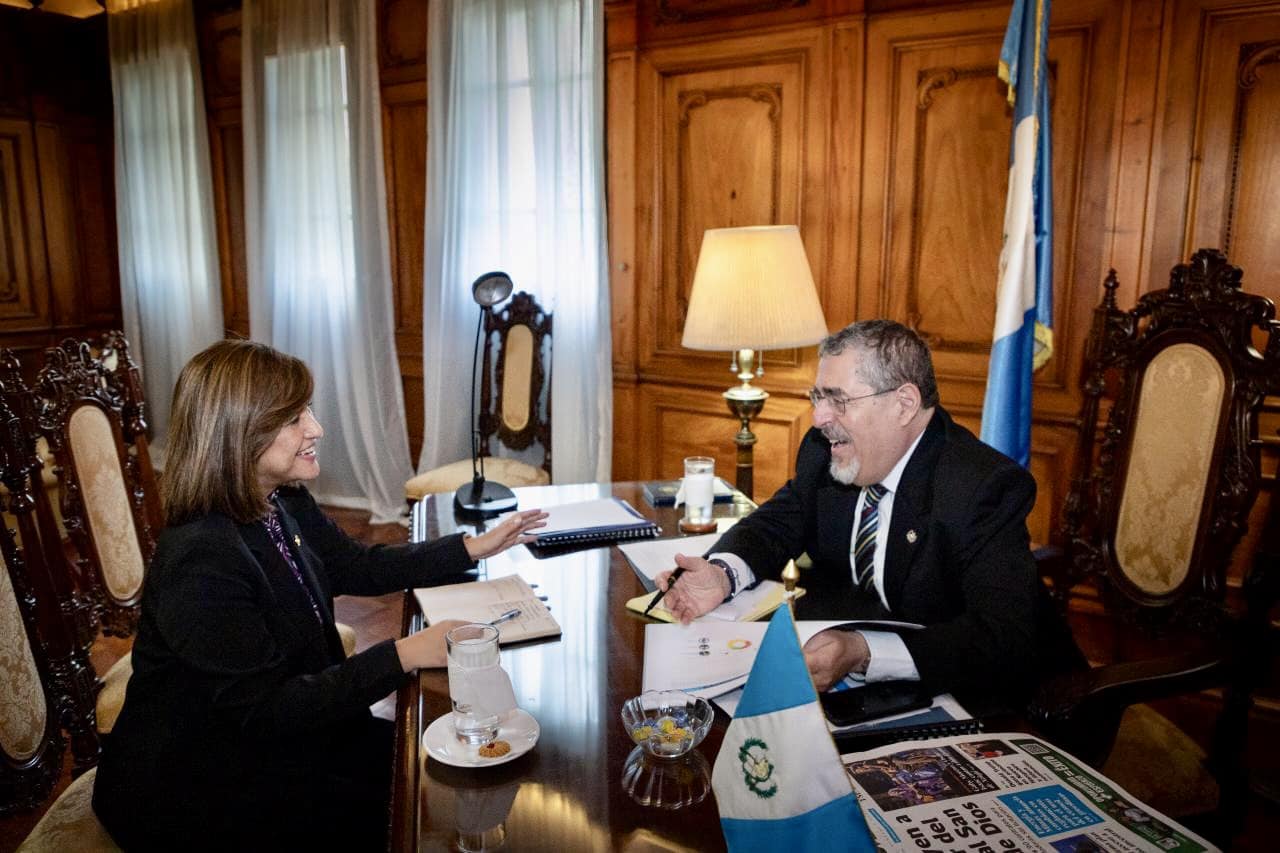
left=0, top=10, right=120, bottom=361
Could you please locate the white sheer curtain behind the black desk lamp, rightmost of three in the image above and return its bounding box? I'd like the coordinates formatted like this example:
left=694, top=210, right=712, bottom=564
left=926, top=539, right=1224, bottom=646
left=419, top=0, right=613, bottom=483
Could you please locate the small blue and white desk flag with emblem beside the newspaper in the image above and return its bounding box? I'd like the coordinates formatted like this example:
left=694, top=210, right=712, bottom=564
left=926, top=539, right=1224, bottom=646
left=712, top=607, right=876, bottom=853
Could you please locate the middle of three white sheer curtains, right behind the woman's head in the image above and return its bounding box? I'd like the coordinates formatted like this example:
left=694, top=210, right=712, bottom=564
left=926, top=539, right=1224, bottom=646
left=241, top=0, right=411, bottom=521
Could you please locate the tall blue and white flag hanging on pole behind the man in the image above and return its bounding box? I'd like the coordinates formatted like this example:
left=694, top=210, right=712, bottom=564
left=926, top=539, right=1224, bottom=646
left=982, top=0, right=1053, bottom=466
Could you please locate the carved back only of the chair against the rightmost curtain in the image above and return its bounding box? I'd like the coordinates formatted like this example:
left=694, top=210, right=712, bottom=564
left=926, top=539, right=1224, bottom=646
left=480, top=291, right=552, bottom=474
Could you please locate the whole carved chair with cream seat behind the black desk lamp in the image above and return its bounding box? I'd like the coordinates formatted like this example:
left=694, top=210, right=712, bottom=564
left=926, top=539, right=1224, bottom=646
left=404, top=292, right=552, bottom=502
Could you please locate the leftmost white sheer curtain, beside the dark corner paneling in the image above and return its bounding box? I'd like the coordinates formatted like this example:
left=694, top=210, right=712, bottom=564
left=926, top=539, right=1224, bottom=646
left=108, top=0, right=223, bottom=461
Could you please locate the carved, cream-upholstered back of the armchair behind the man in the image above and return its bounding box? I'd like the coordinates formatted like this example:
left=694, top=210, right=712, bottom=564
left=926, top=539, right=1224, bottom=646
left=1055, top=250, right=1280, bottom=614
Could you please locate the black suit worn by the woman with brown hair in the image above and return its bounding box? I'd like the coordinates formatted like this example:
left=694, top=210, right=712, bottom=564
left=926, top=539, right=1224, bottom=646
left=93, top=488, right=474, bottom=849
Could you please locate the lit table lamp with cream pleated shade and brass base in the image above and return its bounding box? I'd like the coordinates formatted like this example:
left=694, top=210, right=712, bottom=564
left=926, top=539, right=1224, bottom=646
left=681, top=225, right=827, bottom=497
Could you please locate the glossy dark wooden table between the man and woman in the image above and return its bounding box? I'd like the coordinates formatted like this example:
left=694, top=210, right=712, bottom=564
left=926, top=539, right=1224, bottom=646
left=390, top=483, right=754, bottom=853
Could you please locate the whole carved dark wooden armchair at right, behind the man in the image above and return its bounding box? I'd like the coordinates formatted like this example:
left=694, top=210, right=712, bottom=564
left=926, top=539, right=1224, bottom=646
left=1030, top=250, right=1280, bottom=831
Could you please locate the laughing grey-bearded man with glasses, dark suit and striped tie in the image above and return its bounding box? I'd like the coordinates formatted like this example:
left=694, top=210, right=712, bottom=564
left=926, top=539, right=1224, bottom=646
left=658, top=320, right=1083, bottom=707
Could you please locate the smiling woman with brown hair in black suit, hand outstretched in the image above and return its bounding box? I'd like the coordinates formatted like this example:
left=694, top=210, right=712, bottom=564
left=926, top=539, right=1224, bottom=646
left=93, top=341, right=545, bottom=850
